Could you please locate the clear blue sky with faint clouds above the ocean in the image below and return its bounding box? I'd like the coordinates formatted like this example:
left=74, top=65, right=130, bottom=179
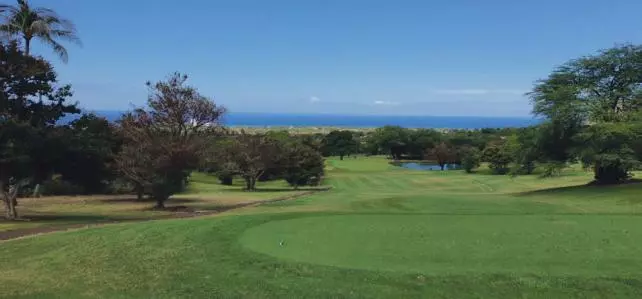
left=27, top=0, right=642, bottom=116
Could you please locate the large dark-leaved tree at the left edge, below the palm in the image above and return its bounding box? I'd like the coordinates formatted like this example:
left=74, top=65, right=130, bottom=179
left=0, top=42, right=79, bottom=219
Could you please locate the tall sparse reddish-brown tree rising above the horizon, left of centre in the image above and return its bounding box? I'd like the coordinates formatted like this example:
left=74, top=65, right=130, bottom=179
left=116, top=73, right=225, bottom=208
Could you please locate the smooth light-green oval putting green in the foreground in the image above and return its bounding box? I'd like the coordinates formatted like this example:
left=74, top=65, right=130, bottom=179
left=240, top=215, right=642, bottom=276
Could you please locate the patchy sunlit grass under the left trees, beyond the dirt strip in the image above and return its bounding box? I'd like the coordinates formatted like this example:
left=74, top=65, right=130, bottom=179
left=0, top=173, right=306, bottom=231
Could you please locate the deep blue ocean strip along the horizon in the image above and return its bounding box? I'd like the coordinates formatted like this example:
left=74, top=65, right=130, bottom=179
left=62, top=111, right=541, bottom=129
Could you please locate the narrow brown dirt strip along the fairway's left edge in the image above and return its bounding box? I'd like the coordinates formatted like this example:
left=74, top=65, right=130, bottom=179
left=0, top=187, right=332, bottom=241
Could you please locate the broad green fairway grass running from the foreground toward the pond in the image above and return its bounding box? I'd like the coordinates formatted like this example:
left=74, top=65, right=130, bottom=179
left=0, top=158, right=642, bottom=298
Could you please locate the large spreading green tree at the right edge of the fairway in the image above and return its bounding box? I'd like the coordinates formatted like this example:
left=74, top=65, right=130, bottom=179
left=531, top=45, right=642, bottom=183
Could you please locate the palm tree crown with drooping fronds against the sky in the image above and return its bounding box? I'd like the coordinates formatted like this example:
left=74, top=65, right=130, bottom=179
left=0, top=0, right=80, bottom=63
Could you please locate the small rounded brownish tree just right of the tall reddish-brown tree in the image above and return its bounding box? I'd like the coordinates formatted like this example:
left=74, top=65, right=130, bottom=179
left=214, top=132, right=283, bottom=191
